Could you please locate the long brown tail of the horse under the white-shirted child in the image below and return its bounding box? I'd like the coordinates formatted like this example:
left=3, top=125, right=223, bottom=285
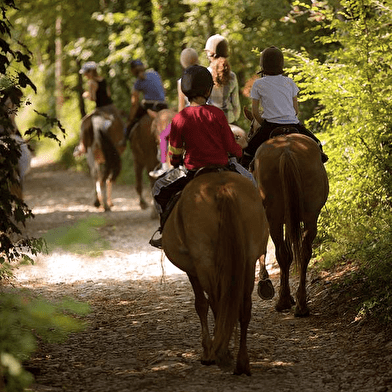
left=279, top=150, right=304, bottom=268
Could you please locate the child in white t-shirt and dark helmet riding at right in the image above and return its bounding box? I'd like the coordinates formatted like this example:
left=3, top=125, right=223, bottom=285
left=241, top=46, right=328, bottom=167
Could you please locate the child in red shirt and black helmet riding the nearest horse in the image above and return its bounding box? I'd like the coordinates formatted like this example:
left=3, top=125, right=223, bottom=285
left=150, top=65, right=242, bottom=248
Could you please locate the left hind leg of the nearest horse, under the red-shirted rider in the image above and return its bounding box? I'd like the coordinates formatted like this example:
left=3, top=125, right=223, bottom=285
left=188, top=274, right=215, bottom=365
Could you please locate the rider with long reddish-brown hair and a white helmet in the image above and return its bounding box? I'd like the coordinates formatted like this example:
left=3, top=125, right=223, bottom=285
left=204, top=34, right=241, bottom=124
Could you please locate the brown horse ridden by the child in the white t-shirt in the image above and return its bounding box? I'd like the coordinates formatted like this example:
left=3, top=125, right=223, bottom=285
left=248, top=108, right=329, bottom=317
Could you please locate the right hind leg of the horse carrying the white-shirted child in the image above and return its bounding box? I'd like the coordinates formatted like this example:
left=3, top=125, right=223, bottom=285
left=295, top=221, right=317, bottom=317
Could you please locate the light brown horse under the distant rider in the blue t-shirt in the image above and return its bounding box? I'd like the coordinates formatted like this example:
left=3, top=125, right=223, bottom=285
left=131, top=109, right=175, bottom=209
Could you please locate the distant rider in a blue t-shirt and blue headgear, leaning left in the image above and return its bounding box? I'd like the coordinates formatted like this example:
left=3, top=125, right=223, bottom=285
left=122, top=59, right=167, bottom=145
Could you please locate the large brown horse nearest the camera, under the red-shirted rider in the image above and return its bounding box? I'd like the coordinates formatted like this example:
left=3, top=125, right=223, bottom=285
left=162, top=172, right=268, bottom=375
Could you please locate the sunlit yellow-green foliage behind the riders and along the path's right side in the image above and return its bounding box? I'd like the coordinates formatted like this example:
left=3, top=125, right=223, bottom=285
left=4, top=0, right=392, bottom=324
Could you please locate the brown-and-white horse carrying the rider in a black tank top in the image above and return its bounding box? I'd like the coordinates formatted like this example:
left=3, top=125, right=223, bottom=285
left=75, top=105, right=124, bottom=211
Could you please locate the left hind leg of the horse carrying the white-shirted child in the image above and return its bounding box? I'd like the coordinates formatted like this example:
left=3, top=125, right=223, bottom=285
left=270, top=222, right=295, bottom=312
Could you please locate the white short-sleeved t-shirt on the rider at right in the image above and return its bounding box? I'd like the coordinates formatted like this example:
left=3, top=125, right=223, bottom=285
left=250, top=75, right=299, bottom=124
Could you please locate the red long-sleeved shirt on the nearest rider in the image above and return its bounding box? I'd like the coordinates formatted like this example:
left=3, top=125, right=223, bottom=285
left=169, top=105, right=242, bottom=169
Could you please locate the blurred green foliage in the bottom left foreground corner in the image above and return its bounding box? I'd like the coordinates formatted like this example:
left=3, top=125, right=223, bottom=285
left=0, top=293, right=89, bottom=392
